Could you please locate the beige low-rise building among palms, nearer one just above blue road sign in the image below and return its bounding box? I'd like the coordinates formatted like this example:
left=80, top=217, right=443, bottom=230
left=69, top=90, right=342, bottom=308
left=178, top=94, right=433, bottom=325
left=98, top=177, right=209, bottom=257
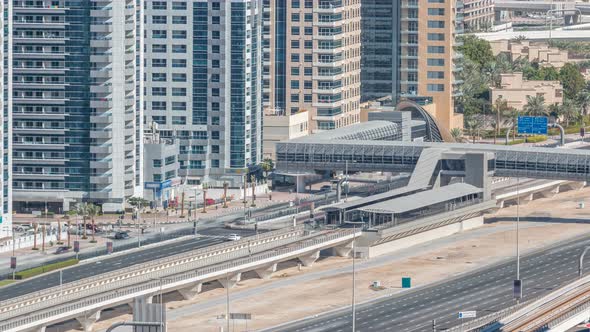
left=491, top=72, right=563, bottom=110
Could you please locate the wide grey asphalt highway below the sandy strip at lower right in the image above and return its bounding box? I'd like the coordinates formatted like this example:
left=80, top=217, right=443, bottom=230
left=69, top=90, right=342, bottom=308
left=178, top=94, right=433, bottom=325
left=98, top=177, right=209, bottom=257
left=280, top=237, right=590, bottom=332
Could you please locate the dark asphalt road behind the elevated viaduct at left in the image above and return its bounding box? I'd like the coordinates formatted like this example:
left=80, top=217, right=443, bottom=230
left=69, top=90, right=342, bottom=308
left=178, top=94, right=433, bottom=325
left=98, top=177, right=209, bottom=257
left=0, top=228, right=260, bottom=301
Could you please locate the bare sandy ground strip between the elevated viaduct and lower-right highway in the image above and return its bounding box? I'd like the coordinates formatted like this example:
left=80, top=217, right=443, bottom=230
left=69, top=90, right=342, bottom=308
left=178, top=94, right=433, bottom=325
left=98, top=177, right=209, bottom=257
left=48, top=188, right=590, bottom=332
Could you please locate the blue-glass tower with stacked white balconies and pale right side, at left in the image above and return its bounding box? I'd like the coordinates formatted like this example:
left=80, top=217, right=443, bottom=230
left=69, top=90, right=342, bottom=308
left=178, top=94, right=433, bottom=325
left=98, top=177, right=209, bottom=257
left=10, top=0, right=141, bottom=212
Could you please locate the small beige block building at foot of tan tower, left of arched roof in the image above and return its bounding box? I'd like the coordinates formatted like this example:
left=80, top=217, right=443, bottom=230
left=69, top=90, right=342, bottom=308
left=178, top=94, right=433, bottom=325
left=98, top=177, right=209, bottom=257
left=262, top=109, right=310, bottom=160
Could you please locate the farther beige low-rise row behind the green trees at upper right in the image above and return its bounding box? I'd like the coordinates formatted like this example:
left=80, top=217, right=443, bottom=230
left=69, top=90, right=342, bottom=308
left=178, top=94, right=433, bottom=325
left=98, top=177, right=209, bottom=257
left=490, top=40, right=570, bottom=69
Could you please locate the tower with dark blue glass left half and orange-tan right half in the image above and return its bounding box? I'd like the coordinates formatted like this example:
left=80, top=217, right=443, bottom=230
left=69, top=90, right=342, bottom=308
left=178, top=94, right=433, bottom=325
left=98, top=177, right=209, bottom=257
left=362, top=0, right=464, bottom=130
